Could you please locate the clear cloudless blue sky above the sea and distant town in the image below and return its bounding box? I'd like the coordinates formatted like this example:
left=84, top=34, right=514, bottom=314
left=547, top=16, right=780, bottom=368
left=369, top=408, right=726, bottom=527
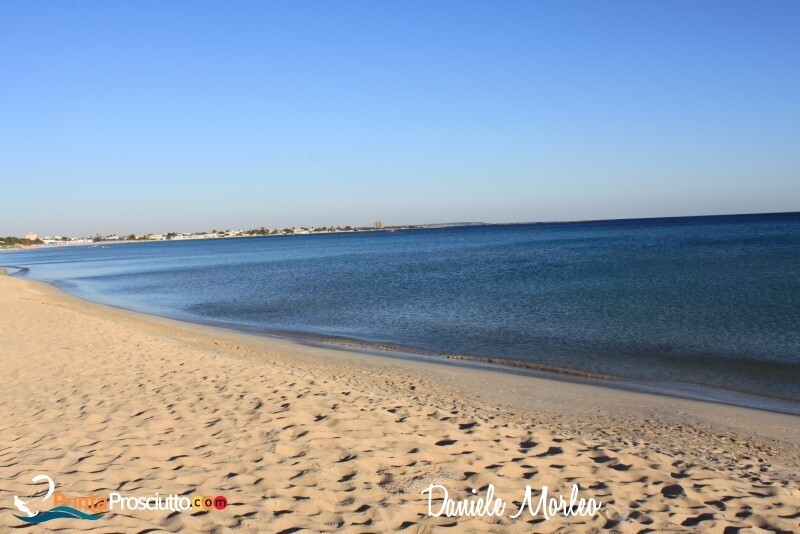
left=0, top=0, right=800, bottom=235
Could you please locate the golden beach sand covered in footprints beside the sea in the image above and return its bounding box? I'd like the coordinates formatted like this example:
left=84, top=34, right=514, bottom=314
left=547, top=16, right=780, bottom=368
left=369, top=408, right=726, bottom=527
left=0, top=276, right=800, bottom=532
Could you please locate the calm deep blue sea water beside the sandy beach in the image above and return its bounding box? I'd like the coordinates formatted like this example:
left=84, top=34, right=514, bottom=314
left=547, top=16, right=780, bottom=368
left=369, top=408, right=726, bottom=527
left=6, top=213, right=800, bottom=411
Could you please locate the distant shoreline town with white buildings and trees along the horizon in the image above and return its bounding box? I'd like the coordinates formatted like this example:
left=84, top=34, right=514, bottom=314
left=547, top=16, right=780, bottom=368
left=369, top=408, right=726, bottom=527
left=0, top=221, right=484, bottom=250
